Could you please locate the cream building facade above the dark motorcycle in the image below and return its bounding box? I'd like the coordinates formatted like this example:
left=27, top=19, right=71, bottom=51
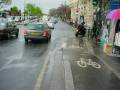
left=69, top=0, right=94, bottom=26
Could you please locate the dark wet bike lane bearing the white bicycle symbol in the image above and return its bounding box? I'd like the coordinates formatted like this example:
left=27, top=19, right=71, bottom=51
left=63, top=38, right=120, bottom=90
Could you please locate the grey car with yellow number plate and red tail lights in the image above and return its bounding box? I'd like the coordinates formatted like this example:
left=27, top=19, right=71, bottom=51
left=24, top=22, right=51, bottom=43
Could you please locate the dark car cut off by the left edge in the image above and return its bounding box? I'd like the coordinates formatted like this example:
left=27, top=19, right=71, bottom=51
left=0, top=22, right=19, bottom=39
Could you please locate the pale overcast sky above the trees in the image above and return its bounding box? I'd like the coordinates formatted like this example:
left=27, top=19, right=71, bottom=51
left=6, top=0, right=68, bottom=13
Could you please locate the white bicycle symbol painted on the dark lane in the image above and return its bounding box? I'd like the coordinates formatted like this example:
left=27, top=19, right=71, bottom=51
left=77, top=58, right=101, bottom=69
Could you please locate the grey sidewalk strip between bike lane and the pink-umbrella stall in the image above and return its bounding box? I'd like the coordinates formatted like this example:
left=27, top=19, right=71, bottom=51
left=88, top=40, right=120, bottom=79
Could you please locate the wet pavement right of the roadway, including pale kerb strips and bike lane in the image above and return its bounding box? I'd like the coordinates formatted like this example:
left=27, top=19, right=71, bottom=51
left=40, top=38, right=120, bottom=90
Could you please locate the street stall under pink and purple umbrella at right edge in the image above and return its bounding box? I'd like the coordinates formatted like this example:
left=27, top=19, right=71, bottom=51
left=101, top=9, right=120, bottom=55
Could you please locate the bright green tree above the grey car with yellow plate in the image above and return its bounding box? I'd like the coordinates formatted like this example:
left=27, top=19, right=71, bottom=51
left=25, top=3, right=42, bottom=16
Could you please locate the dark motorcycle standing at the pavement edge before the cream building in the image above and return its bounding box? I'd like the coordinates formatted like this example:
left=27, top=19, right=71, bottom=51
left=75, top=22, right=86, bottom=37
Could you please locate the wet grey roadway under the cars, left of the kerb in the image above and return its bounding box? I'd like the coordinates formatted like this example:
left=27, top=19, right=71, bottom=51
left=0, top=22, right=73, bottom=90
